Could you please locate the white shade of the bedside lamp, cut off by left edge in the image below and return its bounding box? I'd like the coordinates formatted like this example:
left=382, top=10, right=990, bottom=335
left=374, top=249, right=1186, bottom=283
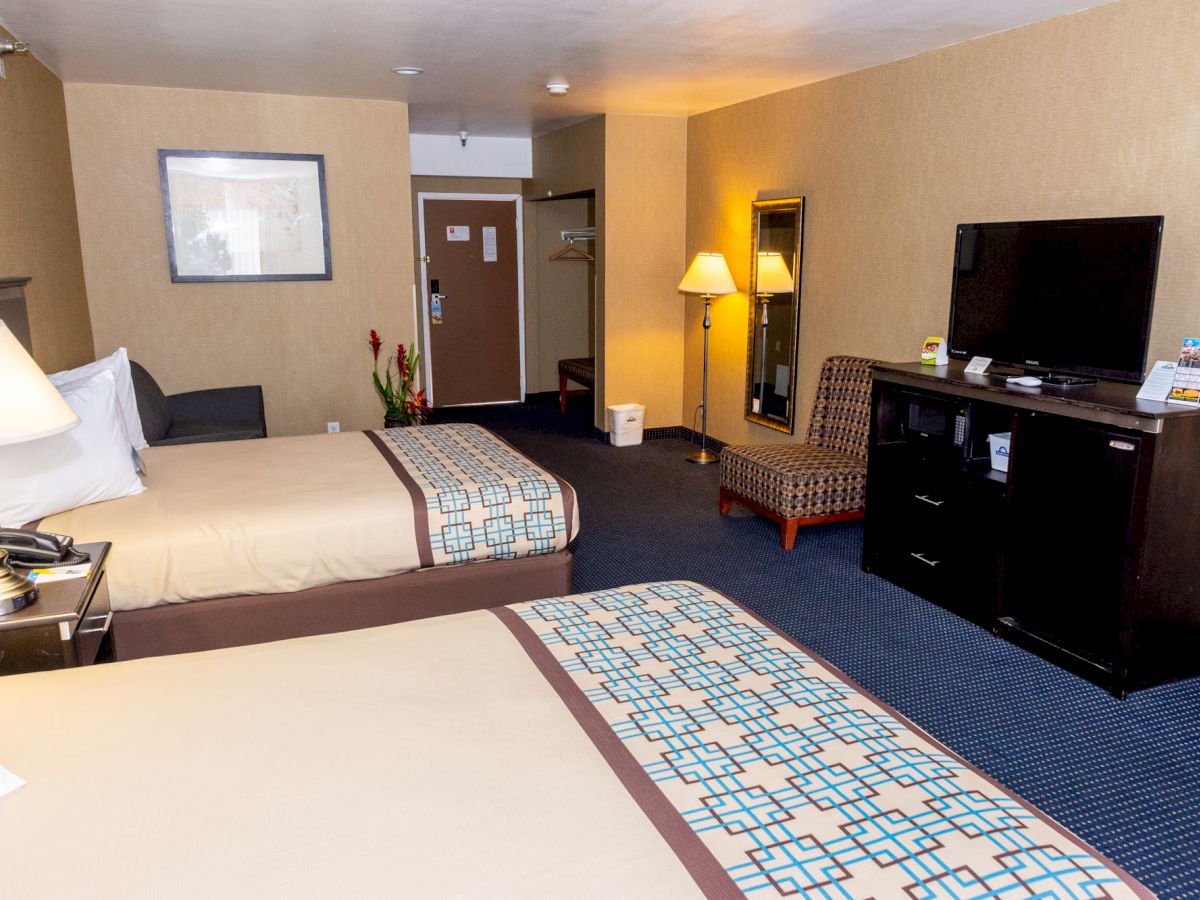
left=0, top=322, right=79, bottom=444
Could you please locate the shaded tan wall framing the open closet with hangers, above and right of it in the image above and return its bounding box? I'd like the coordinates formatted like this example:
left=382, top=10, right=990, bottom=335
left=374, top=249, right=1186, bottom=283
left=526, top=116, right=607, bottom=427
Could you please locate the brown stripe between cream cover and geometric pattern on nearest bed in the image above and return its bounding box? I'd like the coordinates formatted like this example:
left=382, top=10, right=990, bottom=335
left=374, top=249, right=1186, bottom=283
left=491, top=606, right=743, bottom=898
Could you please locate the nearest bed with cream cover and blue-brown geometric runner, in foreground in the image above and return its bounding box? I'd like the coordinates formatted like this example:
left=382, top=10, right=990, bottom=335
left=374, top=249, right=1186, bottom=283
left=0, top=582, right=1150, bottom=898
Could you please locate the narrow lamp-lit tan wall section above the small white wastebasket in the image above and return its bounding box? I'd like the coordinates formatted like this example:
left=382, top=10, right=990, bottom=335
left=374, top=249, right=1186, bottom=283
left=604, top=115, right=701, bottom=428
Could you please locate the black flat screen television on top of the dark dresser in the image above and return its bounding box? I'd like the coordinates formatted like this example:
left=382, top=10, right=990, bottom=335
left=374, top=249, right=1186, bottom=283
left=949, top=216, right=1163, bottom=383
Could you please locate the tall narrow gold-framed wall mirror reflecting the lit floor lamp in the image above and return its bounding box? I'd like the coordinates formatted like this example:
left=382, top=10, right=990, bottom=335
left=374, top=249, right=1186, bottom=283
left=745, top=197, right=804, bottom=433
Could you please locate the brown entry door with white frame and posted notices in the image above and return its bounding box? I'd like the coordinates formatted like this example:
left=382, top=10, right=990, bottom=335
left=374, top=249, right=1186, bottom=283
left=420, top=197, right=522, bottom=407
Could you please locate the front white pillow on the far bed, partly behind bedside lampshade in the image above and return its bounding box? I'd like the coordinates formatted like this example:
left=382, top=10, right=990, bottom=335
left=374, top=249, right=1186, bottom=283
left=0, top=371, right=145, bottom=528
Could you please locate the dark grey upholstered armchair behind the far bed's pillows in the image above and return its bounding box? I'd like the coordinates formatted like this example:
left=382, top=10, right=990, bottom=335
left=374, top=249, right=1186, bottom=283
left=130, top=360, right=266, bottom=446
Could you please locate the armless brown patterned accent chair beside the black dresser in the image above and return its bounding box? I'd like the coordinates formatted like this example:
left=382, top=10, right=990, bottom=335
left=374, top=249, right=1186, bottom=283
left=721, top=356, right=875, bottom=550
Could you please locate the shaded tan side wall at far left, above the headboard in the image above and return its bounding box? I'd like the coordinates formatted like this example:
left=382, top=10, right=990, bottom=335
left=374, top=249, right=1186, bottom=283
left=0, top=29, right=92, bottom=372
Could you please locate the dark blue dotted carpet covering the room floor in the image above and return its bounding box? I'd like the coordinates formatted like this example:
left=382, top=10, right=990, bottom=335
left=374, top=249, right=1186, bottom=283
left=437, top=396, right=1200, bottom=898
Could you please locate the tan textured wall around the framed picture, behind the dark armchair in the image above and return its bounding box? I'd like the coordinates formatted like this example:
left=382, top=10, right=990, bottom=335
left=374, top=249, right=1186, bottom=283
left=66, top=84, right=414, bottom=434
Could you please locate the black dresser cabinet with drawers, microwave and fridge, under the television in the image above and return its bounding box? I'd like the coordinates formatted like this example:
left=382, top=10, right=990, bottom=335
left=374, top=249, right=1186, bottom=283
left=863, top=362, right=1200, bottom=696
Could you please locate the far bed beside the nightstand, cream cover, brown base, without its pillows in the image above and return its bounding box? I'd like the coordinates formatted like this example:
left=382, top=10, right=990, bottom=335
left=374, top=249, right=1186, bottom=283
left=38, top=425, right=578, bottom=659
